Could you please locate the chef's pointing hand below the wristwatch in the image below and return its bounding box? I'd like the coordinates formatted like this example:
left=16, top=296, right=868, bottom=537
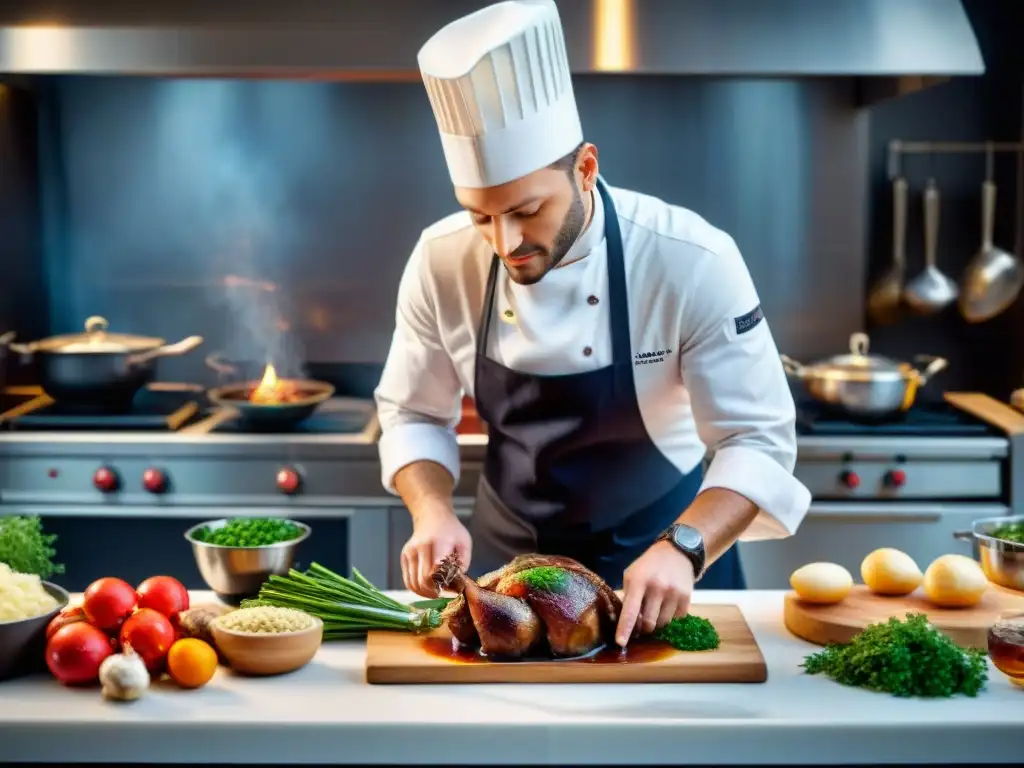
left=615, top=542, right=693, bottom=648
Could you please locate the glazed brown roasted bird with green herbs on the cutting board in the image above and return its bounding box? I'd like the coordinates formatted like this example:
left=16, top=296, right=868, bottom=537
left=433, top=554, right=623, bottom=658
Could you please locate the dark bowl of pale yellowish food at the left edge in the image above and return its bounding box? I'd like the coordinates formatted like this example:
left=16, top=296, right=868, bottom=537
left=0, top=562, right=71, bottom=680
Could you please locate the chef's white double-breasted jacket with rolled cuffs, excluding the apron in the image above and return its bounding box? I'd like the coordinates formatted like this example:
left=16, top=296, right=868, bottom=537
left=375, top=181, right=811, bottom=541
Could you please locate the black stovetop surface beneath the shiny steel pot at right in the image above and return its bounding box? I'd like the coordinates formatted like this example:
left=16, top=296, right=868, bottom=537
left=797, top=400, right=997, bottom=437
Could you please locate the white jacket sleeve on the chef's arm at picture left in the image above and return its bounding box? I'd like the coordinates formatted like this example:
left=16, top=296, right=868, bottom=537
left=374, top=240, right=462, bottom=494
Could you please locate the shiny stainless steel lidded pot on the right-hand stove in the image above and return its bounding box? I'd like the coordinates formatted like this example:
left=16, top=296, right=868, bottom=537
left=779, top=333, right=946, bottom=418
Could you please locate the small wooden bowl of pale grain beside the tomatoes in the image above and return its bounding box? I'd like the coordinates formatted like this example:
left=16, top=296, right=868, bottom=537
left=210, top=605, right=324, bottom=675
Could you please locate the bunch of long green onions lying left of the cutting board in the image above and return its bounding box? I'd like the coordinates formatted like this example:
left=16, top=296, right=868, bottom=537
left=242, top=562, right=441, bottom=640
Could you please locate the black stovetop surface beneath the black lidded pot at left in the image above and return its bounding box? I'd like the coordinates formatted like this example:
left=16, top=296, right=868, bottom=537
left=8, top=385, right=202, bottom=431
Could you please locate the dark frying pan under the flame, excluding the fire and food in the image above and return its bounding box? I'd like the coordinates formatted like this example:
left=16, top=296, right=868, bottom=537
left=206, top=355, right=335, bottom=432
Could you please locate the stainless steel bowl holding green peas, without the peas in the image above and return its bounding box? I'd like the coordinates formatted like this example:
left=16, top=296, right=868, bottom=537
left=185, top=517, right=312, bottom=605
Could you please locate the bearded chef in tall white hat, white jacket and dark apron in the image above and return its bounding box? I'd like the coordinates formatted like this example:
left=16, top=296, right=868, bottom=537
left=375, top=0, right=810, bottom=645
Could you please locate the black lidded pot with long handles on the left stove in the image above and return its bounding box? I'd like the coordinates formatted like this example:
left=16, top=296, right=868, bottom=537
left=7, top=316, right=203, bottom=410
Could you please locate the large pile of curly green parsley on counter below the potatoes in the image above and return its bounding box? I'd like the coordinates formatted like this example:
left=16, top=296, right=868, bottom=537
left=802, top=613, right=988, bottom=697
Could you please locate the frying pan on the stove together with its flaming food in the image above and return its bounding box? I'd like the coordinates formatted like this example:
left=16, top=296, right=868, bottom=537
left=206, top=355, right=335, bottom=432
